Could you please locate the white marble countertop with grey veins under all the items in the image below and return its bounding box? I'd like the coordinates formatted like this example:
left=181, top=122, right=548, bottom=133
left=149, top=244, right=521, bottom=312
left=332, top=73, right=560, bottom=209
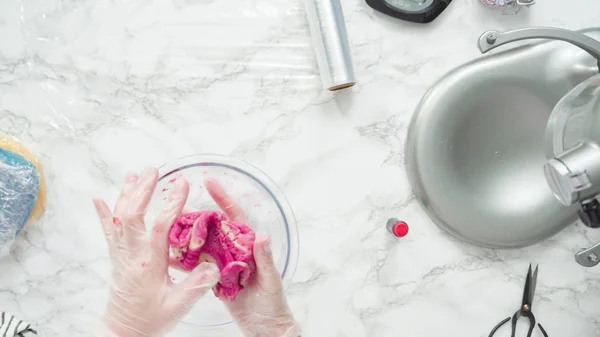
left=0, top=0, right=600, bottom=337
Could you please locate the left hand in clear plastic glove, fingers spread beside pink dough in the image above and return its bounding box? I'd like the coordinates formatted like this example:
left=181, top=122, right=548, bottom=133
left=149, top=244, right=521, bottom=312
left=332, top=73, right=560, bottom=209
left=94, top=169, right=219, bottom=337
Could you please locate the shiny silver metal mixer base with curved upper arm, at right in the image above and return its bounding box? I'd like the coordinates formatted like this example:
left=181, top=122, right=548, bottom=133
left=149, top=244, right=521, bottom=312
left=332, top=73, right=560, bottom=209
left=406, top=28, right=600, bottom=248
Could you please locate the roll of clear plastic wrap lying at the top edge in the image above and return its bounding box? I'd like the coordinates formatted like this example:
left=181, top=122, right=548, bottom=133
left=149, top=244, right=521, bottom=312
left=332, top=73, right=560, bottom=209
left=304, top=0, right=356, bottom=91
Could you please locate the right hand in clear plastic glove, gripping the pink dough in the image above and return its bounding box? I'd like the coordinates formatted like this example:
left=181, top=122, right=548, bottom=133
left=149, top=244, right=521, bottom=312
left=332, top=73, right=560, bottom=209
left=204, top=179, right=300, bottom=337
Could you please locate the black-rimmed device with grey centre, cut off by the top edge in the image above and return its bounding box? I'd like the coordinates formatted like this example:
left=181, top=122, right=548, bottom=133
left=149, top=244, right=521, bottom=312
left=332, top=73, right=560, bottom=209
left=366, top=0, right=452, bottom=23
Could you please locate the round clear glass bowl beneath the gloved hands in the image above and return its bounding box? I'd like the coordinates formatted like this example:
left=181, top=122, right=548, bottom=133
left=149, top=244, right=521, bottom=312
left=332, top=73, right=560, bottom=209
left=146, top=155, right=298, bottom=334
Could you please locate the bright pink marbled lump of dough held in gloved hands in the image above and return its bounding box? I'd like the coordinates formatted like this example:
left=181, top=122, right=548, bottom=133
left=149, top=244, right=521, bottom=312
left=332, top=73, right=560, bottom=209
left=169, top=211, right=256, bottom=301
